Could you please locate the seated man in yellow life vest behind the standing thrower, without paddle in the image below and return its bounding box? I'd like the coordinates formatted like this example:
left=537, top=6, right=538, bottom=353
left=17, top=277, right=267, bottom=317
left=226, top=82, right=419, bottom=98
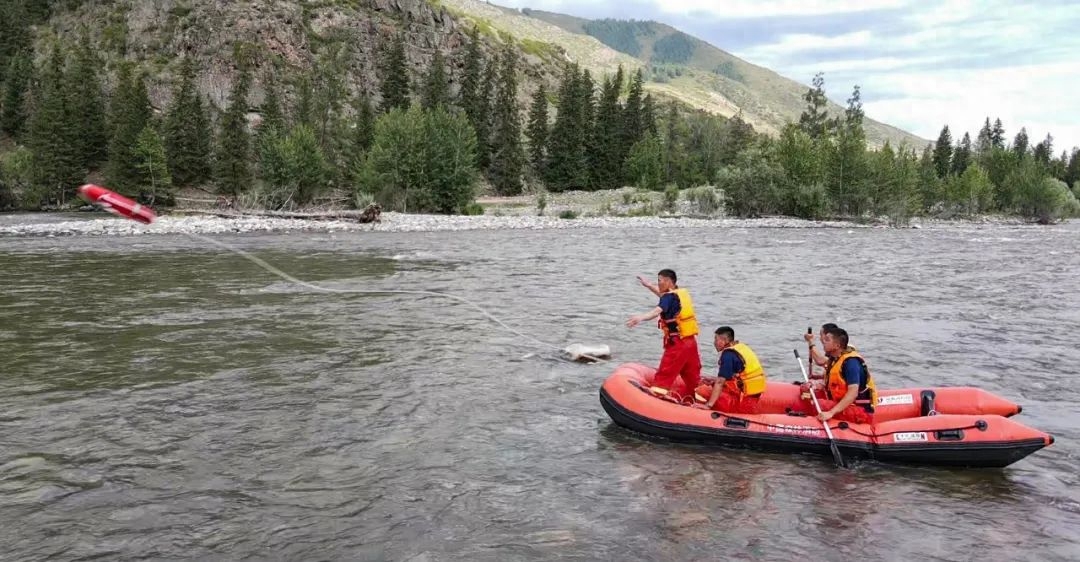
left=694, top=326, right=766, bottom=414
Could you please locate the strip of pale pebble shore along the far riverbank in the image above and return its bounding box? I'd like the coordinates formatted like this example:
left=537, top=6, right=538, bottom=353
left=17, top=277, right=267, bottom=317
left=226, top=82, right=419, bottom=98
left=0, top=188, right=1045, bottom=237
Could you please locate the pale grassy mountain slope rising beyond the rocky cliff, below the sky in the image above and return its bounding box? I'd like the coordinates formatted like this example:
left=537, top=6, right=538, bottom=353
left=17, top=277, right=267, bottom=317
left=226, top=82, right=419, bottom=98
left=440, top=0, right=929, bottom=147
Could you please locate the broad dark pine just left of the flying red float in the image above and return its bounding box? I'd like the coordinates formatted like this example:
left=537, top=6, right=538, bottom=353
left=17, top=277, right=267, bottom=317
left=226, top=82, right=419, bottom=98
left=27, top=48, right=85, bottom=204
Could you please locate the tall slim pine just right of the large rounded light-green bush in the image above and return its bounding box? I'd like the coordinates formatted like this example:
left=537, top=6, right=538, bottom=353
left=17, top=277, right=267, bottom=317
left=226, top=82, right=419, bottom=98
left=488, top=43, right=525, bottom=196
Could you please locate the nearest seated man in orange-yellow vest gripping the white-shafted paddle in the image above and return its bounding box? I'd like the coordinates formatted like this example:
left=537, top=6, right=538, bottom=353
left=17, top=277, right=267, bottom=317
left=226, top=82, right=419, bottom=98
left=802, top=327, right=877, bottom=424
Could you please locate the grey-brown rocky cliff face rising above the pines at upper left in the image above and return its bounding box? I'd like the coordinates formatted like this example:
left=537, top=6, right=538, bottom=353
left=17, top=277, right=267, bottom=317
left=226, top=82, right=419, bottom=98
left=39, top=0, right=561, bottom=117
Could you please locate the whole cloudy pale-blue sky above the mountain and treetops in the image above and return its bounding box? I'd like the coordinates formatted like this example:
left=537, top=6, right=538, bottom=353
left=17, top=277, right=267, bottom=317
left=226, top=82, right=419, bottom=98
left=492, top=0, right=1080, bottom=153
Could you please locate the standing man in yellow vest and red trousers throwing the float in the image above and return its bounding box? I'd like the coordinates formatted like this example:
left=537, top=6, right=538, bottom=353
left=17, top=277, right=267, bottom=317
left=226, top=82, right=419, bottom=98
left=626, top=269, right=701, bottom=401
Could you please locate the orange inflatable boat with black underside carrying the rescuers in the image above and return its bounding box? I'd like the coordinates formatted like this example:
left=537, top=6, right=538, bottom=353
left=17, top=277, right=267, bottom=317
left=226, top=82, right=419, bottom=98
left=600, top=363, right=1054, bottom=467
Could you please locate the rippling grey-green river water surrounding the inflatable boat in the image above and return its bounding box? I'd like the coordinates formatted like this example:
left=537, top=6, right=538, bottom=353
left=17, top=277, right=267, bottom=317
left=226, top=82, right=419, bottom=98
left=0, top=217, right=1080, bottom=561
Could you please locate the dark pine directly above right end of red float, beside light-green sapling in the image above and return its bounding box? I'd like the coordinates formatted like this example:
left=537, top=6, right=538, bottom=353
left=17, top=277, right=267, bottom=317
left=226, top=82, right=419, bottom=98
left=105, top=64, right=151, bottom=195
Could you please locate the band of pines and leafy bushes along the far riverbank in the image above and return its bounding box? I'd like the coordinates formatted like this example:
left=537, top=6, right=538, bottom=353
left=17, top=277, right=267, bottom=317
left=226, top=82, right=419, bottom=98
left=0, top=1, right=1080, bottom=226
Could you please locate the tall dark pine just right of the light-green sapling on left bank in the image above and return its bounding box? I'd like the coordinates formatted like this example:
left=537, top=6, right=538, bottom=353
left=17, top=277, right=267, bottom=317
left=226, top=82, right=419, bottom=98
left=164, top=57, right=212, bottom=186
